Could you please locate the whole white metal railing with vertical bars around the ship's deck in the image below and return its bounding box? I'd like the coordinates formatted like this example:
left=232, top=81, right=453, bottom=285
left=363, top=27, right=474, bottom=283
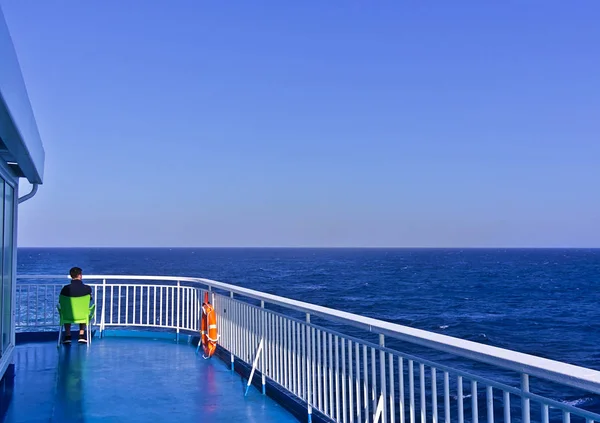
left=16, top=276, right=600, bottom=423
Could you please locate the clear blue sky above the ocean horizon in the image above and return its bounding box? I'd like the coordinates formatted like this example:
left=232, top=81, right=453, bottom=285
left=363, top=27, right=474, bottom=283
left=1, top=0, right=600, bottom=247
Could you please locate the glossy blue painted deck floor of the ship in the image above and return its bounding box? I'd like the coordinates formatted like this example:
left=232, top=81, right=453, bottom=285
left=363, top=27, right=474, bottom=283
left=5, top=338, right=297, bottom=423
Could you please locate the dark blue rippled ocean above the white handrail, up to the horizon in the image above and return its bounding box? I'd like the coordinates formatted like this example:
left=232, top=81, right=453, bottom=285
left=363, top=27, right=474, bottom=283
left=18, top=248, right=600, bottom=370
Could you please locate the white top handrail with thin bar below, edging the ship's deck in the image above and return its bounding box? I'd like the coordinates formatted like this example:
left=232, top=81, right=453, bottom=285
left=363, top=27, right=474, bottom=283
left=17, top=275, right=600, bottom=393
